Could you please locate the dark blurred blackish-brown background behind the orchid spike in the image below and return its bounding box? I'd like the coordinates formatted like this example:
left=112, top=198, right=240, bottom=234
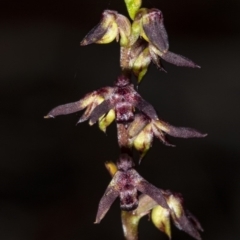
left=0, top=0, right=240, bottom=240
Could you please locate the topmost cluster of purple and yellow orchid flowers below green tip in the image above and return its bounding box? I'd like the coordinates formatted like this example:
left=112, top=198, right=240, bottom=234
left=81, top=7, right=200, bottom=83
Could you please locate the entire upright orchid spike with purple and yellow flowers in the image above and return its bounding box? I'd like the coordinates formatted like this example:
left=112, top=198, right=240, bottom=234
left=45, top=0, right=207, bottom=240
